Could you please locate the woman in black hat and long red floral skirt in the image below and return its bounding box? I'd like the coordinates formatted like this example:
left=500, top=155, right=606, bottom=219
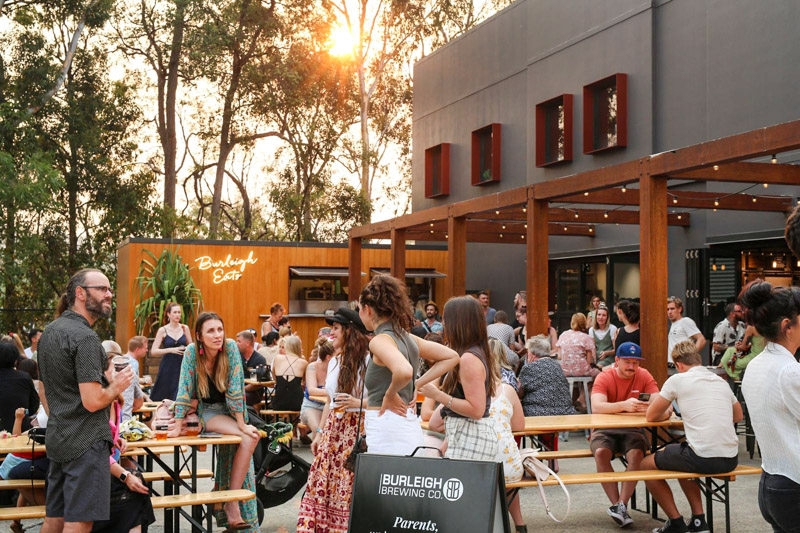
left=297, top=307, right=369, bottom=533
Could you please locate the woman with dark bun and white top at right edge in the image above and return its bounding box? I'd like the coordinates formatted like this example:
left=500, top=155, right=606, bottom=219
left=739, top=280, right=800, bottom=532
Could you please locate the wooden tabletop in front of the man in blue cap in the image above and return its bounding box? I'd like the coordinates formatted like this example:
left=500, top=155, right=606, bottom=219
left=420, top=413, right=683, bottom=435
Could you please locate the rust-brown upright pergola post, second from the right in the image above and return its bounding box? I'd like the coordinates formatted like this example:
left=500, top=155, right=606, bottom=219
left=525, top=187, right=549, bottom=337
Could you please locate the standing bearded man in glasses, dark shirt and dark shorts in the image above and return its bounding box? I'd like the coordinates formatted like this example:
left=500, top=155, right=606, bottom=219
left=38, top=269, right=134, bottom=533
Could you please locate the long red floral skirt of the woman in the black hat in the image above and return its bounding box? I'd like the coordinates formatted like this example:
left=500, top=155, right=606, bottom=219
left=297, top=412, right=364, bottom=533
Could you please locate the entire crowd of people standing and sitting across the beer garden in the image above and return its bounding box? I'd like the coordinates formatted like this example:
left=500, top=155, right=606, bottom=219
left=0, top=269, right=800, bottom=533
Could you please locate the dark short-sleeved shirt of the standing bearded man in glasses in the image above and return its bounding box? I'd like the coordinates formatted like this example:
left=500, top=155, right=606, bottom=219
left=38, top=310, right=112, bottom=463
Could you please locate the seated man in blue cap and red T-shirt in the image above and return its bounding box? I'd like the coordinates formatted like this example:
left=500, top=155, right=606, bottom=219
left=589, top=342, right=671, bottom=527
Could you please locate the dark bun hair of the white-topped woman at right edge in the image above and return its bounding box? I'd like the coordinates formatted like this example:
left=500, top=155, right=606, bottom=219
left=739, top=279, right=800, bottom=342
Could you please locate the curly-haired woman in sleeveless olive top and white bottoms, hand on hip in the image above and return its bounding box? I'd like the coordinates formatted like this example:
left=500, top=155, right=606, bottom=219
left=359, top=275, right=458, bottom=455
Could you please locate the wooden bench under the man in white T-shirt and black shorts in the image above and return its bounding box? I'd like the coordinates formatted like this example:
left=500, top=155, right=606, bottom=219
left=506, top=464, right=761, bottom=533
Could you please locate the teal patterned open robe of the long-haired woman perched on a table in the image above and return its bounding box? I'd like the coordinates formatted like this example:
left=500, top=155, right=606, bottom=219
left=175, top=339, right=259, bottom=533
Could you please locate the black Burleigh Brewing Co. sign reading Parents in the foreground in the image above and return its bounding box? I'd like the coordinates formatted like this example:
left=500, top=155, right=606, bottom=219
left=348, top=453, right=510, bottom=533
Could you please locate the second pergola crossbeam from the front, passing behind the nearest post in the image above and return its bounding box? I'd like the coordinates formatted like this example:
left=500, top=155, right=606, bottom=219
left=558, top=188, right=792, bottom=212
